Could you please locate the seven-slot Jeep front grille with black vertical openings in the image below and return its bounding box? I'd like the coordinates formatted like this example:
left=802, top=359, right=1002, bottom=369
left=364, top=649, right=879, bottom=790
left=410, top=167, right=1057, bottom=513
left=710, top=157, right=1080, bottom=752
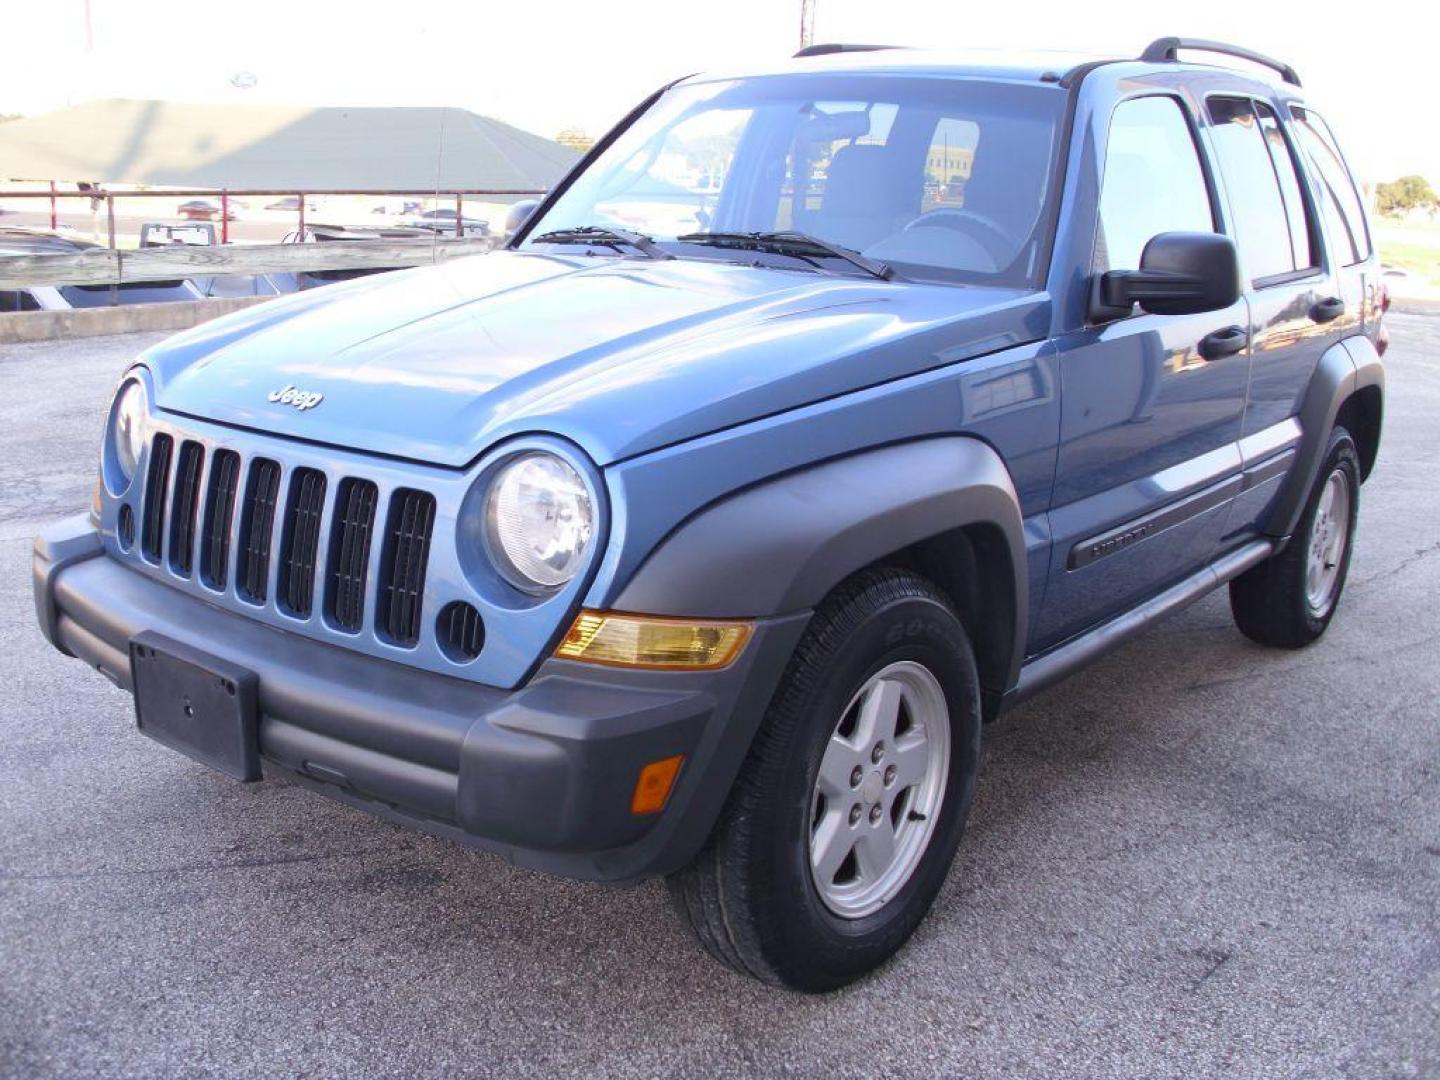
left=132, top=432, right=440, bottom=657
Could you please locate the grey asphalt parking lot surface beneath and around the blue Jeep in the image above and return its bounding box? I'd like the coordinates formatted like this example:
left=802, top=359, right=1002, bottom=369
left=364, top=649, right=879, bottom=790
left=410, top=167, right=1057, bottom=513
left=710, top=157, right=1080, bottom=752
left=0, top=315, right=1440, bottom=1077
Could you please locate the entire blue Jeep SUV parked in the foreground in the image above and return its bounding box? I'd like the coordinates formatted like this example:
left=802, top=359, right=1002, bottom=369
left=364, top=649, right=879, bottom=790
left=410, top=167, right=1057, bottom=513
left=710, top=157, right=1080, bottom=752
left=35, top=39, right=1387, bottom=991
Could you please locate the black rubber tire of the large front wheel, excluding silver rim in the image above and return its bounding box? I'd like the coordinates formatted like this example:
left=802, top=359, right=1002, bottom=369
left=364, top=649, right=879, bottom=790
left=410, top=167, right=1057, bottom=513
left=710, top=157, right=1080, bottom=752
left=668, top=570, right=981, bottom=992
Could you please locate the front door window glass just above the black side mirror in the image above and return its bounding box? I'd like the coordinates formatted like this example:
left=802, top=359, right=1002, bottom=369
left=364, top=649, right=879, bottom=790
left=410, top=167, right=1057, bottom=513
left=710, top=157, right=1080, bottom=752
left=1094, top=96, right=1215, bottom=271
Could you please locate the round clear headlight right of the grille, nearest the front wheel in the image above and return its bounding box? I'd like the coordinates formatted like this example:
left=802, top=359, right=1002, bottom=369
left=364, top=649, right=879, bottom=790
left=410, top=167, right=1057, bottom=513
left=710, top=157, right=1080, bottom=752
left=485, top=452, right=595, bottom=593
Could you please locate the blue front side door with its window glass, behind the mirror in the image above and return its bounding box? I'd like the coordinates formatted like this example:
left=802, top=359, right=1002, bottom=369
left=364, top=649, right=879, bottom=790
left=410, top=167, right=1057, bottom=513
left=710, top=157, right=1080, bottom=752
left=1031, top=92, right=1250, bottom=649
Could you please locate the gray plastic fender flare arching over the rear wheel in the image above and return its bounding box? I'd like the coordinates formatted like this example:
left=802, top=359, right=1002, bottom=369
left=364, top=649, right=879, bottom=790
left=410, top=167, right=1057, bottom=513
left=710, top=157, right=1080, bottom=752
left=1264, top=337, right=1385, bottom=537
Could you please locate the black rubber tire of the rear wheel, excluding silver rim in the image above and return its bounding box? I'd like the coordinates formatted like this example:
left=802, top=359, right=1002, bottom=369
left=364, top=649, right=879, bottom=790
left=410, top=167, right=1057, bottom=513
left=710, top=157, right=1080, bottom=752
left=1230, top=428, right=1359, bottom=649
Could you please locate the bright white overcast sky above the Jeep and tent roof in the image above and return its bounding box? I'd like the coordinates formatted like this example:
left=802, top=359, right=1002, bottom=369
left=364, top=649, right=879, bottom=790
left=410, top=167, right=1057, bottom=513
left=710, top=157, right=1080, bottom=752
left=0, top=0, right=1440, bottom=184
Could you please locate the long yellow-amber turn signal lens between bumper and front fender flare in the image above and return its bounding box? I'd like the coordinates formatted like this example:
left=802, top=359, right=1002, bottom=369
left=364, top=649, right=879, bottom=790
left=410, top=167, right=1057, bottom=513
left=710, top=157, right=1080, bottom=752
left=554, top=611, right=753, bottom=671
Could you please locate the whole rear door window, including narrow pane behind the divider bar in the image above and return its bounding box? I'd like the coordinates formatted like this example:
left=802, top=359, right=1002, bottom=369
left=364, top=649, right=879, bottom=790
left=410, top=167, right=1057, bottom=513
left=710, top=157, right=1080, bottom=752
left=1210, top=98, right=1315, bottom=284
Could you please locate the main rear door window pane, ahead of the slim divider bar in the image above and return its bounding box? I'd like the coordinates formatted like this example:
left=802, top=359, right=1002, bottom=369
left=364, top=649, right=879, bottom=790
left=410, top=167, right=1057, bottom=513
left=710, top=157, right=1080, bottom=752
left=1210, top=98, right=1309, bottom=279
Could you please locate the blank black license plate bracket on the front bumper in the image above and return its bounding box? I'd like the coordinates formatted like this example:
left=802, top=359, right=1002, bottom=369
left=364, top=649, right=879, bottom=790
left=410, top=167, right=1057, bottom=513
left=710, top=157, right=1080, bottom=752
left=130, top=631, right=261, bottom=780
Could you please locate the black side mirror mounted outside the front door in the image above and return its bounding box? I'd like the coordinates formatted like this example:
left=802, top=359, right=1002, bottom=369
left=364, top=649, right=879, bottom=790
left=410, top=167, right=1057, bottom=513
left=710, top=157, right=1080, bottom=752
left=1090, top=232, right=1240, bottom=323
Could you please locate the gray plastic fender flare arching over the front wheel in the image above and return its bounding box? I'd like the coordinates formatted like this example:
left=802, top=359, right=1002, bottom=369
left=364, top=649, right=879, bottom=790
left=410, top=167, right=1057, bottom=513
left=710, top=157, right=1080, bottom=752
left=613, top=436, right=1028, bottom=694
